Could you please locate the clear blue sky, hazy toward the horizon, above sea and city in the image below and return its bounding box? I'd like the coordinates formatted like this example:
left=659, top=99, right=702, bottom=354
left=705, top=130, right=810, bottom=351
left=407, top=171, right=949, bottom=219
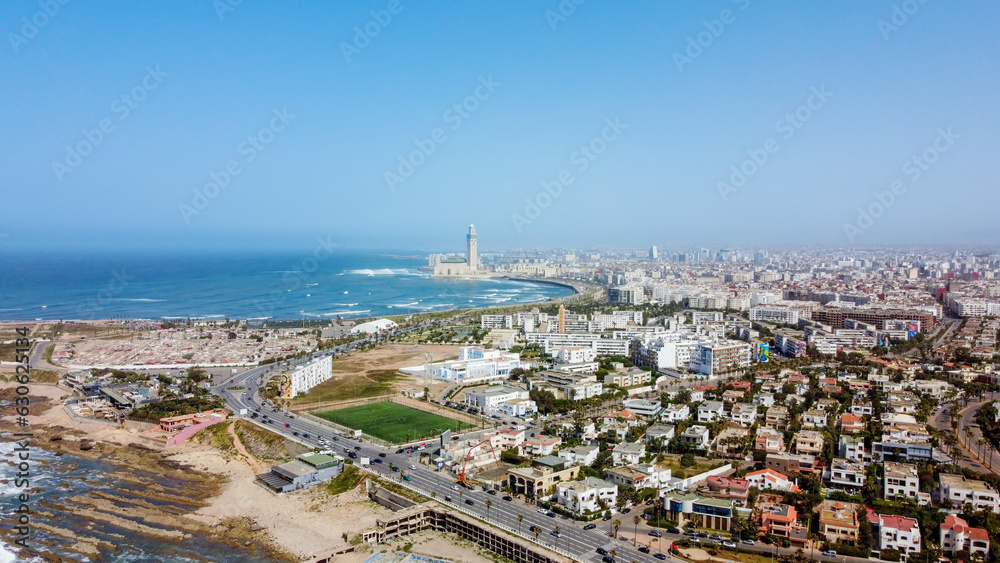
left=0, top=0, right=1000, bottom=250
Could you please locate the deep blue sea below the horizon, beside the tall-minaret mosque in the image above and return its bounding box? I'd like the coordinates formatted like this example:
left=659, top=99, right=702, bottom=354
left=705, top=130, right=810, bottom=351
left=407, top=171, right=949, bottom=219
left=0, top=250, right=573, bottom=320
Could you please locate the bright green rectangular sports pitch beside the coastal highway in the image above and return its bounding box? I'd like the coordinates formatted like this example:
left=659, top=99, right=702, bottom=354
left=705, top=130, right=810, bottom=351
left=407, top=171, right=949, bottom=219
left=313, top=401, right=471, bottom=443
